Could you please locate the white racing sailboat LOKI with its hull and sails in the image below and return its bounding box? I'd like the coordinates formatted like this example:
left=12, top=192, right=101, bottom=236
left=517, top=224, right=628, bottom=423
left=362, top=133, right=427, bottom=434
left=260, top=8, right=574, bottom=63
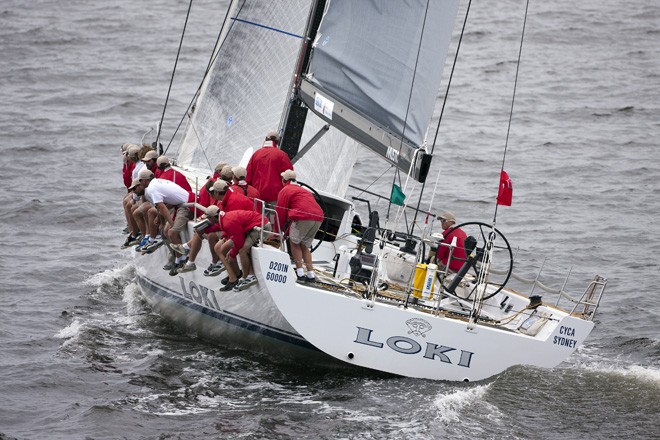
left=135, top=0, right=607, bottom=381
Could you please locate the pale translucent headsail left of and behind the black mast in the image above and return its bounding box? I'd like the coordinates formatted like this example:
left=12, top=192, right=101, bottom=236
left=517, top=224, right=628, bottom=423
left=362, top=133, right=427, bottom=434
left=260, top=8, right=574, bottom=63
left=178, top=0, right=357, bottom=195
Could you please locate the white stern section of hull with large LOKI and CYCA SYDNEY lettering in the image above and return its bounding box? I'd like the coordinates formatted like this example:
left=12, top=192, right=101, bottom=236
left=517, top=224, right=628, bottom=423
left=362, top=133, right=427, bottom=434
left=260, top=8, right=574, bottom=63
left=253, top=249, right=594, bottom=381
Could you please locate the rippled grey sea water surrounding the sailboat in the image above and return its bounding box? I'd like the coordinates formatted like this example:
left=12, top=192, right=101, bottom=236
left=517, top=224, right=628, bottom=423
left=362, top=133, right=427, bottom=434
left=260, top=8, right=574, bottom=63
left=0, top=0, right=660, bottom=439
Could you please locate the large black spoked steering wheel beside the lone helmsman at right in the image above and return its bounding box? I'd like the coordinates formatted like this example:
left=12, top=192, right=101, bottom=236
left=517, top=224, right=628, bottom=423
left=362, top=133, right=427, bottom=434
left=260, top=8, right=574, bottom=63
left=444, top=222, right=513, bottom=299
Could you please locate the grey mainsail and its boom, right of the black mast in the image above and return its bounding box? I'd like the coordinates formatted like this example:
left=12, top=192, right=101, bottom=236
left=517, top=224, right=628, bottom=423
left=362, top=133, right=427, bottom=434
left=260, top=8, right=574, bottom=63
left=301, top=0, right=459, bottom=181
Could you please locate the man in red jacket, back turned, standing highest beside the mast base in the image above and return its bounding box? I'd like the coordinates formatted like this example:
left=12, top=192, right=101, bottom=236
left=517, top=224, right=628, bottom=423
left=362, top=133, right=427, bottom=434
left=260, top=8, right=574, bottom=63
left=245, top=131, right=293, bottom=203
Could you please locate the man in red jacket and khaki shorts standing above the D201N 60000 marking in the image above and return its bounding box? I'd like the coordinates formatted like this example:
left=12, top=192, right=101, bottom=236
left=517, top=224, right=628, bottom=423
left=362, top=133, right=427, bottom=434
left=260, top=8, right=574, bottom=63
left=276, top=170, right=324, bottom=282
